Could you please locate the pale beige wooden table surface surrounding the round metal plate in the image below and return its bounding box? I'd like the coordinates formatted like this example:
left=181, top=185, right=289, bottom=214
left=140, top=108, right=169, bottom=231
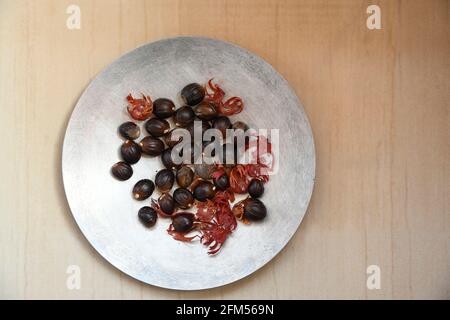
left=0, top=0, right=450, bottom=299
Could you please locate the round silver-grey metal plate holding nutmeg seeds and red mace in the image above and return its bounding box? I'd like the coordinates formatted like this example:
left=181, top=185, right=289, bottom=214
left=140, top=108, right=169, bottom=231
left=62, top=37, right=315, bottom=290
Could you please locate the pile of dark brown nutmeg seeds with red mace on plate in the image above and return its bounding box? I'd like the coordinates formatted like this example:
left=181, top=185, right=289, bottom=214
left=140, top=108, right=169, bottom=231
left=111, top=80, right=271, bottom=254
